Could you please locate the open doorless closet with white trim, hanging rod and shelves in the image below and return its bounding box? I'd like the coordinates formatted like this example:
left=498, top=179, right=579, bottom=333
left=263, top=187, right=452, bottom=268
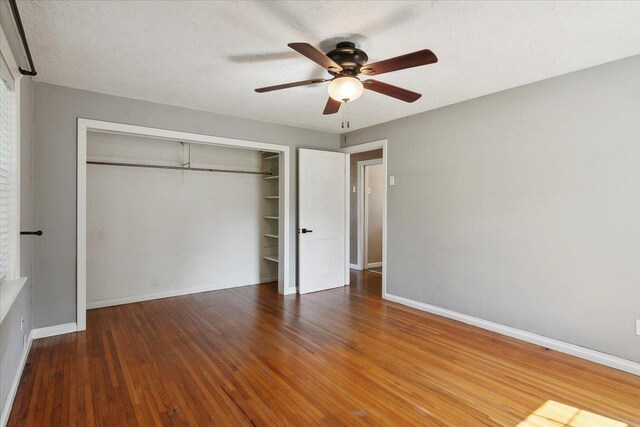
left=77, top=119, right=295, bottom=330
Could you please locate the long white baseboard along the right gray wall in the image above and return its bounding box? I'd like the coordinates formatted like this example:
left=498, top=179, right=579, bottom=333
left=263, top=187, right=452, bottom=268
left=383, top=293, right=640, bottom=376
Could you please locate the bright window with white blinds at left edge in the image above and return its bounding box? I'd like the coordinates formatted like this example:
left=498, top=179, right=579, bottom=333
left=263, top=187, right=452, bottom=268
left=0, top=72, right=19, bottom=281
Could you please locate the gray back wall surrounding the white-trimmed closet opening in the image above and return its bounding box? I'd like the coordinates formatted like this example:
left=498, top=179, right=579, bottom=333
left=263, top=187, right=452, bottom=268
left=33, top=83, right=340, bottom=327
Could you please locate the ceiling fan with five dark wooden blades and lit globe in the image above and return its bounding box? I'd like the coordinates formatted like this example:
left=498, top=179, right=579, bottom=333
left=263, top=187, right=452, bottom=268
left=256, top=41, right=438, bottom=114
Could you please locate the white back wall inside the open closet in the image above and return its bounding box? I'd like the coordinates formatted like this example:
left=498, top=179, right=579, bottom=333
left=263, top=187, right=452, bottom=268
left=87, top=132, right=264, bottom=308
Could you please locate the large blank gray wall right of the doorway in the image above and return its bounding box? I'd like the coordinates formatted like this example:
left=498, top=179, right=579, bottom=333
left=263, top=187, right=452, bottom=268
left=343, top=56, right=640, bottom=362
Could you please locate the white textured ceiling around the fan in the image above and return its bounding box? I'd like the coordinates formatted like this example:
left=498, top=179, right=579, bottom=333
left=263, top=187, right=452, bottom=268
left=19, top=1, right=640, bottom=132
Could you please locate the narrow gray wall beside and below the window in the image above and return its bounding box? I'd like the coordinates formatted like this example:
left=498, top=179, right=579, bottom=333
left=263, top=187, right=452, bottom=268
left=0, top=77, right=34, bottom=413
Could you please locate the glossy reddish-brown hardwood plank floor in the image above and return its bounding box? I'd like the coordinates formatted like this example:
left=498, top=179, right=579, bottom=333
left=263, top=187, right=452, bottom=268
left=9, top=272, right=640, bottom=426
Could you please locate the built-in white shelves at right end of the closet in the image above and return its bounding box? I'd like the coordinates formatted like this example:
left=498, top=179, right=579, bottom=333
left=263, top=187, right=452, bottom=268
left=260, top=152, right=281, bottom=280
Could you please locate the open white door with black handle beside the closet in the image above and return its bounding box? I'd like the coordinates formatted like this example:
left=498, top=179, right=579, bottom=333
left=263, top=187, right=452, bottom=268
left=298, top=148, right=346, bottom=294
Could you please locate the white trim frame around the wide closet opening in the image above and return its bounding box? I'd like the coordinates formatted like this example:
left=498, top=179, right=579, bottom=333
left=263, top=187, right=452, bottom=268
left=75, top=118, right=296, bottom=331
